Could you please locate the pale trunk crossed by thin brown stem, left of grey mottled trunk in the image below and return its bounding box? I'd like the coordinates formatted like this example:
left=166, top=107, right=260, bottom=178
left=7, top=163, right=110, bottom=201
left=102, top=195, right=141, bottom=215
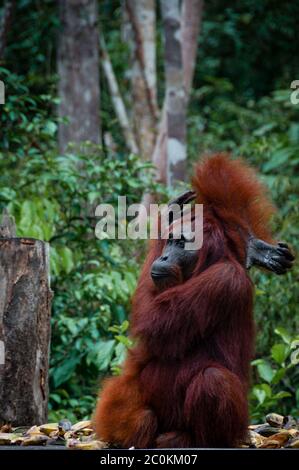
left=127, top=0, right=158, bottom=160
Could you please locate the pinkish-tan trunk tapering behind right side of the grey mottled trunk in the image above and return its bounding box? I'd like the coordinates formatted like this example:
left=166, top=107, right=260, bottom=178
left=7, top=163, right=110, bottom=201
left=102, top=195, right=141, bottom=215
left=182, top=0, right=203, bottom=100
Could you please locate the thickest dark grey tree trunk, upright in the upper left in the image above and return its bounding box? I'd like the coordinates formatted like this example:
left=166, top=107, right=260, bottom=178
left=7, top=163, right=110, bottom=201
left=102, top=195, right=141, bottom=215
left=58, top=0, right=101, bottom=152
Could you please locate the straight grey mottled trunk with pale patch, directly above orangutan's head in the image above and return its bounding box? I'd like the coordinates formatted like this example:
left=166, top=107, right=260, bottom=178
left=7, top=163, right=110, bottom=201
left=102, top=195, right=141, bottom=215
left=161, top=0, right=186, bottom=187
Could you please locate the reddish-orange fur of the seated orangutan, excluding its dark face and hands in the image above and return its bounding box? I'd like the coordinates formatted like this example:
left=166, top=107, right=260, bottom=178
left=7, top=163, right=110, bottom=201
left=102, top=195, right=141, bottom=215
left=94, top=155, right=273, bottom=447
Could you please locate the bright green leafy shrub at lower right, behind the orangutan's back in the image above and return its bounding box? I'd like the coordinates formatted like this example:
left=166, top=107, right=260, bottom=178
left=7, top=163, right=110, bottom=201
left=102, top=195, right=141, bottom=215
left=251, top=328, right=299, bottom=422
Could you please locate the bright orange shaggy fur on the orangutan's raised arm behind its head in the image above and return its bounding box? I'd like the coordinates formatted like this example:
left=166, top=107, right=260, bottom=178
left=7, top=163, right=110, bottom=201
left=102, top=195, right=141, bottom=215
left=192, top=153, right=275, bottom=241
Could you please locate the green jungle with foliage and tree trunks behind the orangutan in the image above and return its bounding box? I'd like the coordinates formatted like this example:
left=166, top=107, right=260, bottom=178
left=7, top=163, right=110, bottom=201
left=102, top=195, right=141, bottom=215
left=0, top=0, right=299, bottom=421
